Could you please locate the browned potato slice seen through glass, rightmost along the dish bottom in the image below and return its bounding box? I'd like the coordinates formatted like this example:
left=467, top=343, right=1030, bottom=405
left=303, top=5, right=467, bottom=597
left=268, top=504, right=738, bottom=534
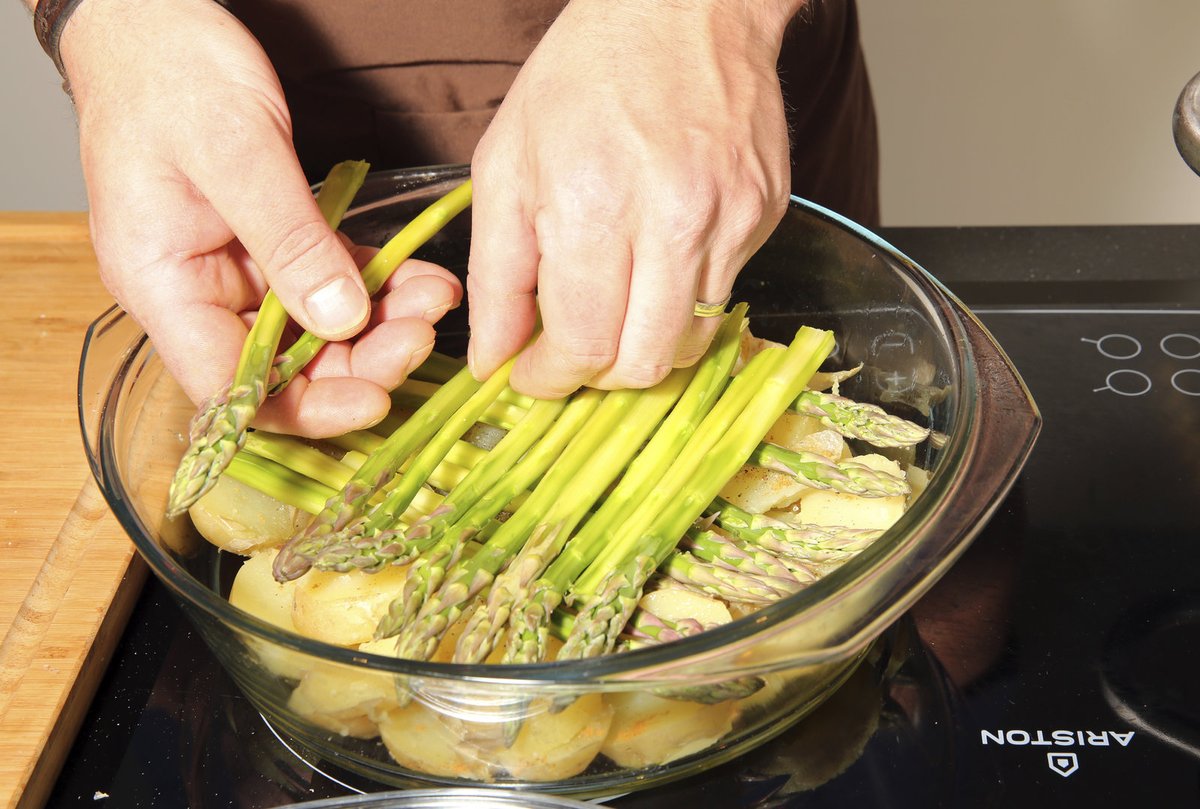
left=600, top=691, right=737, bottom=769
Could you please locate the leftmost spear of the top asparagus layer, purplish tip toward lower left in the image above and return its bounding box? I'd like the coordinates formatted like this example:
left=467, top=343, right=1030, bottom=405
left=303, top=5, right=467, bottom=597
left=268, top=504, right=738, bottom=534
left=274, top=368, right=481, bottom=581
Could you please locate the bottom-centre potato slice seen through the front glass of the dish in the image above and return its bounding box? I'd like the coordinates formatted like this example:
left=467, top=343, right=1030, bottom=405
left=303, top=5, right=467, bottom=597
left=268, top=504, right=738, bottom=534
left=497, top=694, right=612, bottom=781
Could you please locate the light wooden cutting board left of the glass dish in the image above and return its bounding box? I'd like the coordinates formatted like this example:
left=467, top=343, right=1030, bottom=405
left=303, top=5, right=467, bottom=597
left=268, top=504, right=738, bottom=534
left=0, top=212, right=145, bottom=809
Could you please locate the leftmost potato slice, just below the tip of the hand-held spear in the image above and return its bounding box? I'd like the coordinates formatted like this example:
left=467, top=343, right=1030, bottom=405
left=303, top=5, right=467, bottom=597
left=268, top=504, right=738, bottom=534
left=187, top=475, right=308, bottom=556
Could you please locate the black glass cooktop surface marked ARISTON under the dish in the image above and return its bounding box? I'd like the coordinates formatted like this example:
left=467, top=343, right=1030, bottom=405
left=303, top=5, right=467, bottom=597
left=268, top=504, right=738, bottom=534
left=48, top=283, right=1200, bottom=809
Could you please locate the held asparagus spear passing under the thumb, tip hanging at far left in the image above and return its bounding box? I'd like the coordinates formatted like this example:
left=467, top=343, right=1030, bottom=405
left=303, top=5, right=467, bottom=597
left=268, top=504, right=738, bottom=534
left=167, top=161, right=367, bottom=519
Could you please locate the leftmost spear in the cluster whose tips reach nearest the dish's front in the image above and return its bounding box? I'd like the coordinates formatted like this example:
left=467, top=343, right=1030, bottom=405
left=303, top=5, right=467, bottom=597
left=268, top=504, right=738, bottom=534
left=376, top=390, right=604, bottom=637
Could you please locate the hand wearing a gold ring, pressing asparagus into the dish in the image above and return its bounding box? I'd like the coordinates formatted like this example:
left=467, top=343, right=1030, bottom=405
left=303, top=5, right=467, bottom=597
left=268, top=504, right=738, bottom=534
left=468, top=0, right=800, bottom=396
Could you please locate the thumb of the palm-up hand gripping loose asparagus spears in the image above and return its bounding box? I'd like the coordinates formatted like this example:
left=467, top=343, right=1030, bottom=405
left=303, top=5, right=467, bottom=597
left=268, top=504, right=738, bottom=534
left=194, top=117, right=371, bottom=341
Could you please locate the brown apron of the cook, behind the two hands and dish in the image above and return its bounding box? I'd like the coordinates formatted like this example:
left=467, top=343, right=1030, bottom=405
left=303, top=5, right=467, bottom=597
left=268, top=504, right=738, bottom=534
left=224, top=0, right=878, bottom=226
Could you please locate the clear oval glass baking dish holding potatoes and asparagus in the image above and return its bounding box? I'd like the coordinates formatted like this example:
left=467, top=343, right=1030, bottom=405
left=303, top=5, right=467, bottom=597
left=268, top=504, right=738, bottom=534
left=79, top=167, right=1040, bottom=797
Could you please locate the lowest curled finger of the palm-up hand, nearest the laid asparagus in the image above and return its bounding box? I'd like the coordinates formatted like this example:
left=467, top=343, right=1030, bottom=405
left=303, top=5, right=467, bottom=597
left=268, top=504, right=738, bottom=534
left=254, top=376, right=391, bottom=438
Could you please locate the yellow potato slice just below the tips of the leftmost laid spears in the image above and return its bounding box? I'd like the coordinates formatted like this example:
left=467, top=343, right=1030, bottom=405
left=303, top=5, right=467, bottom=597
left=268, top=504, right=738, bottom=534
left=292, top=567, right=408, bottom=646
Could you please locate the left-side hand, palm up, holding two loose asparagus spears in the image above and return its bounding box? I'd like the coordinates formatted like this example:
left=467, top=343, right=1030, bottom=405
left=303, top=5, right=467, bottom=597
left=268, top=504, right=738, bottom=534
left=62, top=0, right=462, bottom=436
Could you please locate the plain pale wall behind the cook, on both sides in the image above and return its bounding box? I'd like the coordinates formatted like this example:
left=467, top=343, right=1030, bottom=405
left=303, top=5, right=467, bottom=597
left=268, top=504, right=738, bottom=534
left=0, top=0, right=1200, bottom=226
